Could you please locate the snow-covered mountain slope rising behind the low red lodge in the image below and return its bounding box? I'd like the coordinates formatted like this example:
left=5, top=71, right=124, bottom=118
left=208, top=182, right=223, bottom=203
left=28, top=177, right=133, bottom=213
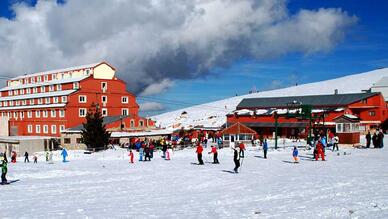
left=152, top=68, right=388, bottom=129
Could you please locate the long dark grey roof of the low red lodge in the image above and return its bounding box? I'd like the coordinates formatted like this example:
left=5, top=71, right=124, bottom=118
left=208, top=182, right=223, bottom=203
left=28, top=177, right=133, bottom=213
left=237, top=93, right=380, bottom=109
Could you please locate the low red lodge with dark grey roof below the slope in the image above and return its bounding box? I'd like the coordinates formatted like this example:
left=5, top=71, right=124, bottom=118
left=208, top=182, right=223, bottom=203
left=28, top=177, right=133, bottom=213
left=227, top=92, right=388, bottom=138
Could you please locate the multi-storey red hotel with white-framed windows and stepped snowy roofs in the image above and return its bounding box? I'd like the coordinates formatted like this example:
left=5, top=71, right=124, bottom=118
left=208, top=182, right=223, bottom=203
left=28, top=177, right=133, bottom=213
left=0, top=62, right=154, bottom=136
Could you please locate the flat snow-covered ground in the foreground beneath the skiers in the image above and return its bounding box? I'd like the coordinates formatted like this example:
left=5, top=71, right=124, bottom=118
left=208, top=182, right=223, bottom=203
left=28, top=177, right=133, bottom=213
left=0, top=138, right=388, bottom=218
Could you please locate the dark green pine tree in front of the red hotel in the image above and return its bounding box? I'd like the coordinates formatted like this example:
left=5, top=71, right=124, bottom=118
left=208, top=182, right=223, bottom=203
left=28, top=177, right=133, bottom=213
left=81, top=103, right=110, bottom=151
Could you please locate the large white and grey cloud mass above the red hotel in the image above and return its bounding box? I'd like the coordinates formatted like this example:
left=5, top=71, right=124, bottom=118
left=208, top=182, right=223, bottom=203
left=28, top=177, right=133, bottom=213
left=0, top=0, right=357, bottom=95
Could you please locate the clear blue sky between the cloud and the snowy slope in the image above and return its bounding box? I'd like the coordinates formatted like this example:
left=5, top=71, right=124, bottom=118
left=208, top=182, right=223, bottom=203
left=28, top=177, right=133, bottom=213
left=0, top=0, right=388, bottom=115
